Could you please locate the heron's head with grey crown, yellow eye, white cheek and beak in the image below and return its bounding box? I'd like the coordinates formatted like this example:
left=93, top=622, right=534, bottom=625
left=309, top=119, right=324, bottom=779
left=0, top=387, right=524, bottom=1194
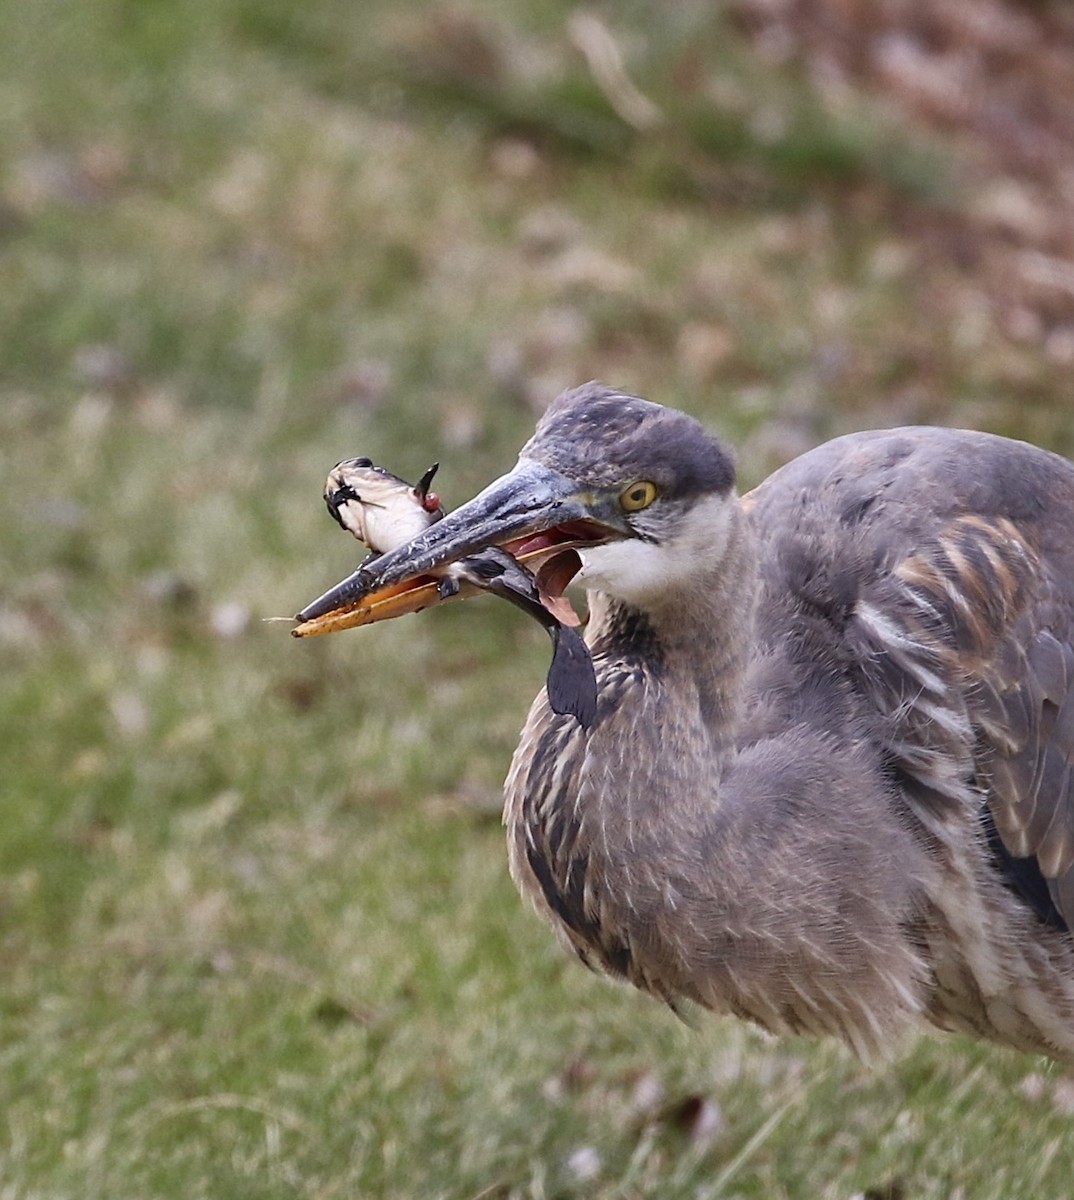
left=296, top=383, right=734, bottom=636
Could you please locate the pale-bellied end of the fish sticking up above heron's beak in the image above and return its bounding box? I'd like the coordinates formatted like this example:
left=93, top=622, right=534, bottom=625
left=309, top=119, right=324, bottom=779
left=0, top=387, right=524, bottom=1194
left=324, top=458, right=444, bottom=554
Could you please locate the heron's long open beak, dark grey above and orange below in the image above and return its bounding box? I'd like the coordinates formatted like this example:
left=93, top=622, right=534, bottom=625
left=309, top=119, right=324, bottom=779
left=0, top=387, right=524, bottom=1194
left=292, top=458, right=631, bottom=637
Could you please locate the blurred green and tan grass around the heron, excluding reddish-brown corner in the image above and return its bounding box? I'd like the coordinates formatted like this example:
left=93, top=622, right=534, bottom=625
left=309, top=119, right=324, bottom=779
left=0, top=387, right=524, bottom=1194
left=0, top=0, right=1074, bottom=1200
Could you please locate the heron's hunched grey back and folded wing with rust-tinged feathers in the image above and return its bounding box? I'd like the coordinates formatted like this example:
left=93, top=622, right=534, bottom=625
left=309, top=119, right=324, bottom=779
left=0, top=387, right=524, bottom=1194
left=746, top=430, right=1074, bottom=929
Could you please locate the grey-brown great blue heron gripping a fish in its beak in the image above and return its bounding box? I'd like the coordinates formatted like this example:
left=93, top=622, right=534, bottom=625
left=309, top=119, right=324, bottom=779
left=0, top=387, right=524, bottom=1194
left=299, top=384, right=1074, bottom=1061
